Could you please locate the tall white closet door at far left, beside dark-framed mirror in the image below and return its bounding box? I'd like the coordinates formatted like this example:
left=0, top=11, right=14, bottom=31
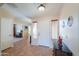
left=1, top=18, right=13, bottom=50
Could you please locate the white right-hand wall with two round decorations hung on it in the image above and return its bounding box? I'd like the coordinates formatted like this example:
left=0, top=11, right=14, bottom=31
left=60, top=4, right=79, bottom=55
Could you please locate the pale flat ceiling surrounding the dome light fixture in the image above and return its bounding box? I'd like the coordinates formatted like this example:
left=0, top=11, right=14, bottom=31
left=9, top=3, right=63, bottom=19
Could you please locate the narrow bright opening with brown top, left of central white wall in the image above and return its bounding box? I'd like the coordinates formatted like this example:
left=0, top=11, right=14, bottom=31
left=31, top=21, right=38, bottom=45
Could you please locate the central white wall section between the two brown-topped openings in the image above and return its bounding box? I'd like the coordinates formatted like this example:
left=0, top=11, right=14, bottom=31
left=32, top=17, right=53, bottom=48
